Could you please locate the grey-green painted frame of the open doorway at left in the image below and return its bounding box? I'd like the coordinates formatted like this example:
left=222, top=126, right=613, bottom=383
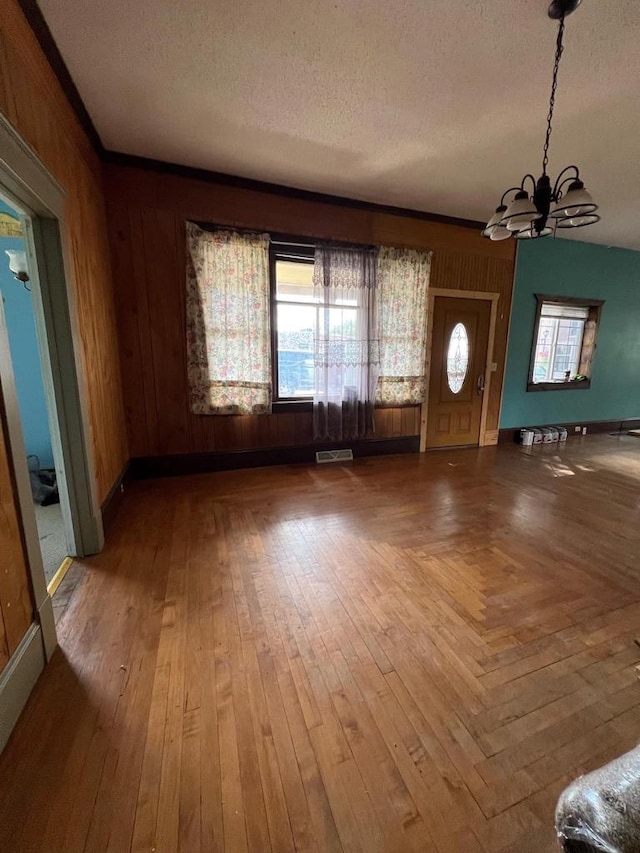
left=0, top=115, right=104, bottom=660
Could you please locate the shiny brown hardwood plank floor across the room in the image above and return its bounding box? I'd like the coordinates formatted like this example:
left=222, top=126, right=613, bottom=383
left=0, top=436, right=640, bottom=853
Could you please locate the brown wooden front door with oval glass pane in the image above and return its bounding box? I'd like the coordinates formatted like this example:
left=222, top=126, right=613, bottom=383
left=427, top=296, right=491, bottom=447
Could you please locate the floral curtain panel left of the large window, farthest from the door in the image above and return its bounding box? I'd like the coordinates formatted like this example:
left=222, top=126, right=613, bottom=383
left=187, top=222, right=271, bottom=415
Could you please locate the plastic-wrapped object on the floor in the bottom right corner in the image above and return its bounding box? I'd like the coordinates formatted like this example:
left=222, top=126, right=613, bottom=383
left=556, top=747, right=640, bottom=853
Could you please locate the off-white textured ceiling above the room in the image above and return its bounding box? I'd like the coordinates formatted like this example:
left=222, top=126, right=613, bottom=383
left=39, top=0, right=640, bottom=249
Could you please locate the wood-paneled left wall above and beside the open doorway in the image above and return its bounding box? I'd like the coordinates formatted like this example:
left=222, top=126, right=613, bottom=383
left=0, top=0, right=128, bottom=500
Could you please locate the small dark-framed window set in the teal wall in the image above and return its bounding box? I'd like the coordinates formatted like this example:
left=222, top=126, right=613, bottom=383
left=527, top=295, right=603, bottom=391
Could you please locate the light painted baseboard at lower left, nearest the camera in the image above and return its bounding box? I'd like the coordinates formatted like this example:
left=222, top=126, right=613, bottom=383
left=0, top=623, right=45, bottom=752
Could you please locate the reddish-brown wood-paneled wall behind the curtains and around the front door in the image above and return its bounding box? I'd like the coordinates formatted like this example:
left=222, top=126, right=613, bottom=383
left=105, top=165, right=515, bottom=456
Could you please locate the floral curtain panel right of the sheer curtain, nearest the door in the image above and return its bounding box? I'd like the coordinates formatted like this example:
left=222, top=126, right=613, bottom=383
left=376, top=246, right=431, bottom=406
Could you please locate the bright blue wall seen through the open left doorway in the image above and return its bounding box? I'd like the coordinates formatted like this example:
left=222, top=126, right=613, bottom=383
left=0, top=201, right=53, bottom=468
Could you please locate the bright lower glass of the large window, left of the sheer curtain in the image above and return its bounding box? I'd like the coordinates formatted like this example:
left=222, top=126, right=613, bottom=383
left=276, top=303, right=318, bottom=397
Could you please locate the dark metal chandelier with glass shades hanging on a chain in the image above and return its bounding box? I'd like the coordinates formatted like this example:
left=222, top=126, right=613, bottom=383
left=482, top=0, right=600, bottom=240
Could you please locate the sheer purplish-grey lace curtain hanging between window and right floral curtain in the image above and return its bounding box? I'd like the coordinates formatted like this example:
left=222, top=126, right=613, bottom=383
left=313, top=246, right=379, bottom=441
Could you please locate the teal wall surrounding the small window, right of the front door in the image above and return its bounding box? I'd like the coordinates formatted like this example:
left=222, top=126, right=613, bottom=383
left=500, top=238, right=640, bottom=429
